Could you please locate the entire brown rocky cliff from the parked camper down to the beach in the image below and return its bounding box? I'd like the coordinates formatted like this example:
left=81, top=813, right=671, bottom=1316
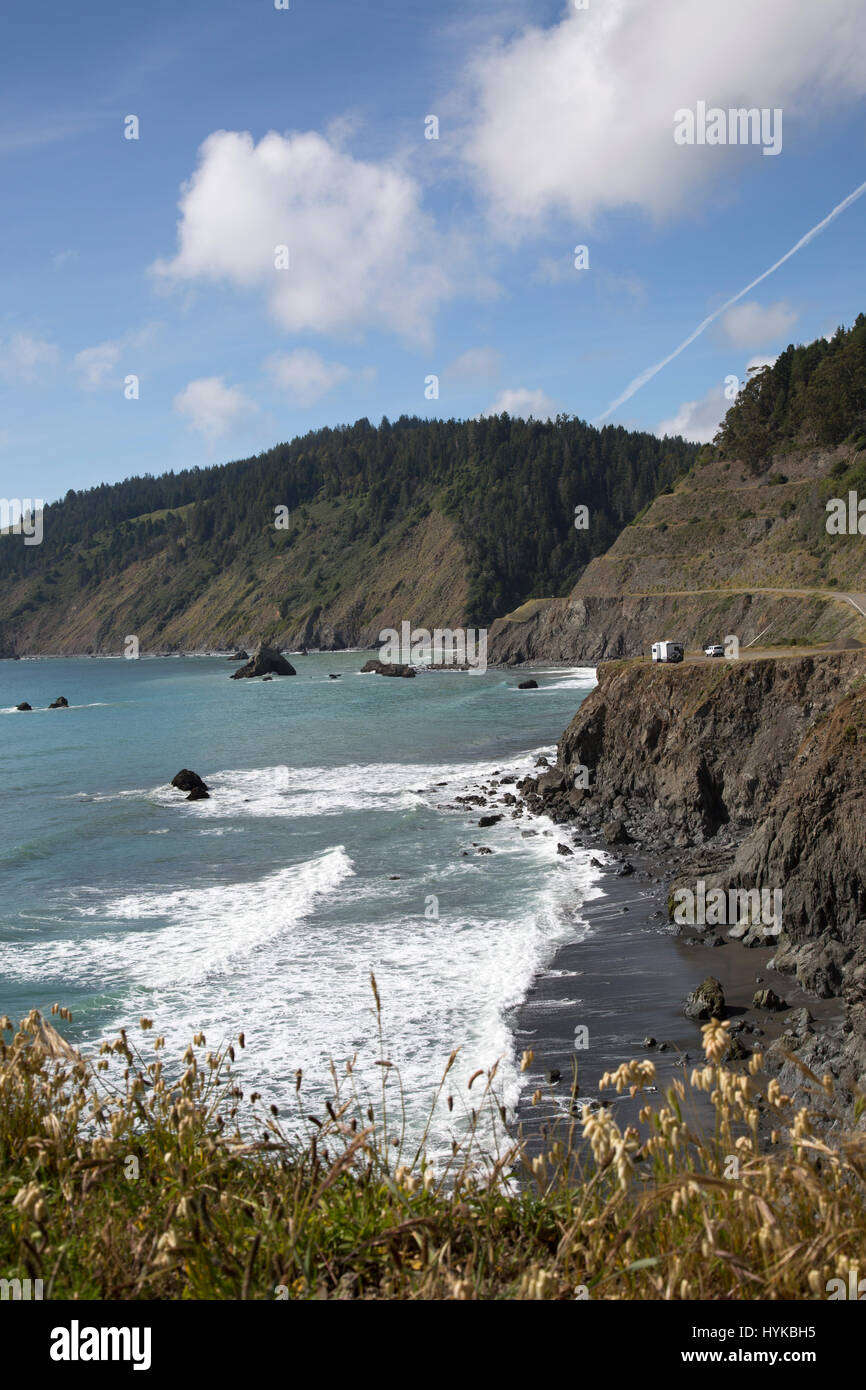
left=544, top=652, right=866, bottom=1094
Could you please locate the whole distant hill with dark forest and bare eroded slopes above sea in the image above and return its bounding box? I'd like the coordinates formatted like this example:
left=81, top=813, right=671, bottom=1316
left=0, top=414, right=696, bottom=653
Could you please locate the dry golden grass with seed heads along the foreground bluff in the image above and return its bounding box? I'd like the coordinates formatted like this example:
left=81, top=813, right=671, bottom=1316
left=0, top=1000, right=866, bottom=1301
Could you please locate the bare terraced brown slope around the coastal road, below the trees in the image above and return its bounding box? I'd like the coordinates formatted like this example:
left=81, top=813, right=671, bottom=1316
left=488, top=446, right=866, bottom=664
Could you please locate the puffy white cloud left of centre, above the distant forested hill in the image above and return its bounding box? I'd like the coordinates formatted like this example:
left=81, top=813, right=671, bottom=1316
left=154, top=131, right=452, bottom=341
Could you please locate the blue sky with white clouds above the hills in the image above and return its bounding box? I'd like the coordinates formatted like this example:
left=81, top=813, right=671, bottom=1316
left=0, top=0, right=866, bottom=511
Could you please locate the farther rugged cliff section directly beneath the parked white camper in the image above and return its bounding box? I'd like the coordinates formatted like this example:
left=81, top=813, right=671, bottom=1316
left=557, top=652, right=865, bottom=848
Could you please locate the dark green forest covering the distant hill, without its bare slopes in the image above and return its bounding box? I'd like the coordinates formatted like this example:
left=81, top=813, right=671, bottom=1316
left=0, top=414, right=696, bottom=632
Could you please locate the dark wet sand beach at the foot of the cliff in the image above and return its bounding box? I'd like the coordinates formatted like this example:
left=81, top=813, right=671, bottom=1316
left=512, top=850, right=841, bottom=1152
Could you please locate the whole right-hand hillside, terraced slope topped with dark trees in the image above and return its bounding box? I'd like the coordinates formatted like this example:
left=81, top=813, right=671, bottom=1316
left=491, top=317, right=866, bottom=662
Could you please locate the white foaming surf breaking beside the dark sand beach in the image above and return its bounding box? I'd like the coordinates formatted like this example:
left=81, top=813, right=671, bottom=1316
left=4, top=748, right=601, bottom=1151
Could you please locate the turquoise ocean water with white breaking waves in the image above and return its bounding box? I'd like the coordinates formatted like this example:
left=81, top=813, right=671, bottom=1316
left=0, top=652, right=601, bottom=1148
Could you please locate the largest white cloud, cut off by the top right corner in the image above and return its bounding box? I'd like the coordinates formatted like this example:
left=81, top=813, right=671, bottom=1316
left=463, top=0, right=866, bottom=236
